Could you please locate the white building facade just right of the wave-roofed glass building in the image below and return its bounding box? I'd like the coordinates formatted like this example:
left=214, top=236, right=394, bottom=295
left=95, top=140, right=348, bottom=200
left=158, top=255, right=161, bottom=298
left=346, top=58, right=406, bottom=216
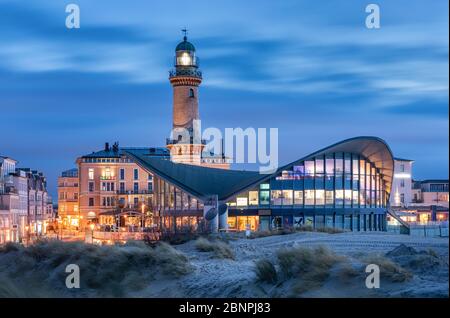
left=389, top=158, right=413, bottom=207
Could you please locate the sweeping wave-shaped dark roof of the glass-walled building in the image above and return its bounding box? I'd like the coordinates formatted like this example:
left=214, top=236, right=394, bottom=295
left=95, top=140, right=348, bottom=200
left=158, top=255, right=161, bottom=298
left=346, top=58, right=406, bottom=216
left=124, top=136, right=394, bottom=201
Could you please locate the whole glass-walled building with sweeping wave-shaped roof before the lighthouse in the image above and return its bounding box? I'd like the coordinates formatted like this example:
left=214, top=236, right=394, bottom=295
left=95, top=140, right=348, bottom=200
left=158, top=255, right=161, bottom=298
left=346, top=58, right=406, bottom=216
left=119, top=137, right=393, bottom=231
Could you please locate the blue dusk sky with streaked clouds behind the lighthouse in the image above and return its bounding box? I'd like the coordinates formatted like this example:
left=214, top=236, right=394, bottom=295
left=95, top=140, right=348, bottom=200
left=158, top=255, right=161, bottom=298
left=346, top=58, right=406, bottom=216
left=0, top=0, right=449, bottom=199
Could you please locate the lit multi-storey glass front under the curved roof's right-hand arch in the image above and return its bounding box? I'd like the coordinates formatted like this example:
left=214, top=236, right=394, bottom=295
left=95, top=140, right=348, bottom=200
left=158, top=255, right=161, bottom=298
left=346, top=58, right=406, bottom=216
left=227, top=152, right=389, bottom=230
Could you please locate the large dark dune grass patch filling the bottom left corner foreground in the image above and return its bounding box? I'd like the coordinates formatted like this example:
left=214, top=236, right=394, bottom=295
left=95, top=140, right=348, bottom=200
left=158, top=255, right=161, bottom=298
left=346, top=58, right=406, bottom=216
left=0, top=241, right=193, bottom=297
